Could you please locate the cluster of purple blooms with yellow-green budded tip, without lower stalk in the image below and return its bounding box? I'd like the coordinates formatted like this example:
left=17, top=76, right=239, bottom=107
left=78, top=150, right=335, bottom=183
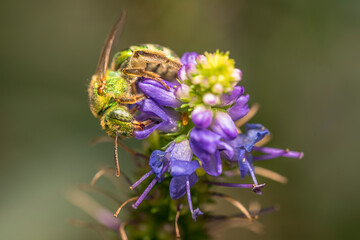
left=131, top=51, right=302, bottom=220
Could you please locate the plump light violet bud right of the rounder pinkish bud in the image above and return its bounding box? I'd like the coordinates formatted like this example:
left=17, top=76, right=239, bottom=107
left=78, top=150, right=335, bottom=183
left=210, top=111, right=238, bottom=140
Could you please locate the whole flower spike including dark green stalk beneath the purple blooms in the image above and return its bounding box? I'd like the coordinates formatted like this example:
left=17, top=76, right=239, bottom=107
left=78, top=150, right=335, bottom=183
left=75, top=51, right=303, bottom=239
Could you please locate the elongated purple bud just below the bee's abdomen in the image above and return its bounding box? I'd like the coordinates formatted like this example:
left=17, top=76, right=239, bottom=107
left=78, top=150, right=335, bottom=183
left=139, top=78, right=181, bottom=108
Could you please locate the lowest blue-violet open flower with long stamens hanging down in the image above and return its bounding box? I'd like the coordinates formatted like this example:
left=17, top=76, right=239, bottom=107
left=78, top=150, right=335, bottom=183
left=130, top=140, right=203, bottom=221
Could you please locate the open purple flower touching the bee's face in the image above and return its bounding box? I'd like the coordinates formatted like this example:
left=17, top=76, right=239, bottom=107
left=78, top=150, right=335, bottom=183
left=135, top=98, right=180, bottom=139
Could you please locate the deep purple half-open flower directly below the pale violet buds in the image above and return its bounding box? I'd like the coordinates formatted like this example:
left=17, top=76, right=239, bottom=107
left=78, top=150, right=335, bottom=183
left=190, top=127, right=234, bottom=176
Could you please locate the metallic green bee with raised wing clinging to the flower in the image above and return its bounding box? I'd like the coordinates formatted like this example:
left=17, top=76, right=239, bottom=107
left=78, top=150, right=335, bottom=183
left=88, top=10, right=181, bottom=176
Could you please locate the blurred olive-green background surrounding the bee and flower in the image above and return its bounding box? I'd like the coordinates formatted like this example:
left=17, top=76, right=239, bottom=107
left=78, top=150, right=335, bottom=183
left=0, top=0, right=360, bottom=240
